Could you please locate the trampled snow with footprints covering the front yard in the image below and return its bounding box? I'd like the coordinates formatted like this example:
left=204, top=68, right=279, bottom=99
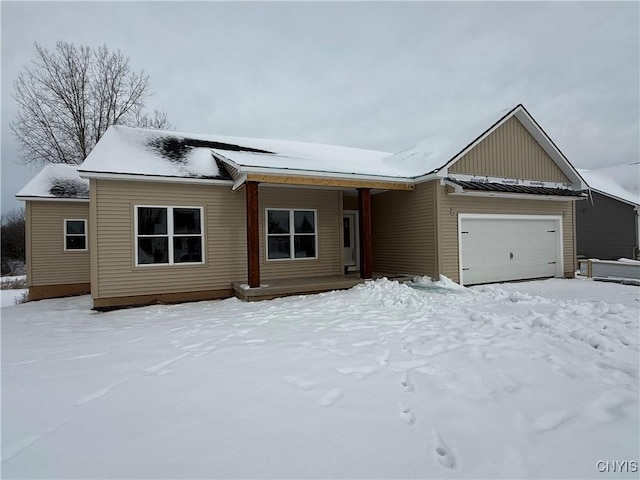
left=2, top=278, right=640, bottom=478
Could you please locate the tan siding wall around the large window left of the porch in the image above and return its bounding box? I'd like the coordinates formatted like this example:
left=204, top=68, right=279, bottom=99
left=92, top=180, right=247, bottom=298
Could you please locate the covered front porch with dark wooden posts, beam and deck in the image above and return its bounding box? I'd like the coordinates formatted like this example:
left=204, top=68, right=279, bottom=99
left=238, top=174, right=413, bottom=294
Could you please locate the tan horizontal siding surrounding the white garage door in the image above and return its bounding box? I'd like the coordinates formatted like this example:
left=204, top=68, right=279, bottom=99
left=438, top=182, right=575, bottom=282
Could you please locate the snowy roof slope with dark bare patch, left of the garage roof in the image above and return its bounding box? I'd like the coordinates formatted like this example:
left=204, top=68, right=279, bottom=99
left=81, top=126, right=401, bottom=179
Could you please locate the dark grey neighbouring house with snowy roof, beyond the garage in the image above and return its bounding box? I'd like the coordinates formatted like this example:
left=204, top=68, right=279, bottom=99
left=576, top=162, right=640, bottom=260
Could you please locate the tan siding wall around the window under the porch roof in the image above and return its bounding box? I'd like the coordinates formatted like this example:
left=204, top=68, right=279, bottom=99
left=259, top=185, right=342, bottom=281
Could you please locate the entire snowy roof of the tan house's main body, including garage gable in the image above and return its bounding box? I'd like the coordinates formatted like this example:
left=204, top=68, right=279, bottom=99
left=66, top=105, right=586, bottom=189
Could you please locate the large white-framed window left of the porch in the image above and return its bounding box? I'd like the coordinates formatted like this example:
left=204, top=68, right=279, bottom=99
left=134, top=205, right=204, bottom=265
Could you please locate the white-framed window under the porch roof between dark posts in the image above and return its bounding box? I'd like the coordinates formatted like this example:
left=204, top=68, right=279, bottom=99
left=265, top=208, right=318, bottom=260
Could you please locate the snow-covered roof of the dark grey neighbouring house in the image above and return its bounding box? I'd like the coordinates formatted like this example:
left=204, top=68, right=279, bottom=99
left=580, top=162, right=640, bottom=206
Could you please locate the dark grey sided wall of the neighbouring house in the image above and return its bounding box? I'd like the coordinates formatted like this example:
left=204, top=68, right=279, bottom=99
left=576, top=192, right=638, bottom=260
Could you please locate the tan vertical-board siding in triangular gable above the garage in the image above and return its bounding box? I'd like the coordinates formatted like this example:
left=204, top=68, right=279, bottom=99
left=449, top=117, right=570, bottom=183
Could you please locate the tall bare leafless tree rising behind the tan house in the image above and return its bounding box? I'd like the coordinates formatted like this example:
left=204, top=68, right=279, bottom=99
left=11, top=41, right=171, bottom=165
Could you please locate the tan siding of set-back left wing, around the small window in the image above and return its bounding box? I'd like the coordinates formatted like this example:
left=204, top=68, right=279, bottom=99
left=26, top=201, right=91, bottom=286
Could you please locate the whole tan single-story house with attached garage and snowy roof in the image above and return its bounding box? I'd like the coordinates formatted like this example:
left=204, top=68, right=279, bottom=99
left=17, top=105, right=587, bottom=309
